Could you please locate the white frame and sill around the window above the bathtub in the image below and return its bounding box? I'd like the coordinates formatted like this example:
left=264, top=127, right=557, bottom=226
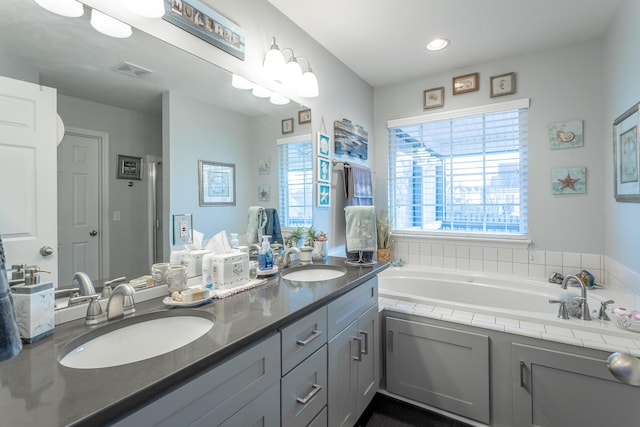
left=387, top=98, right=530, bottom=245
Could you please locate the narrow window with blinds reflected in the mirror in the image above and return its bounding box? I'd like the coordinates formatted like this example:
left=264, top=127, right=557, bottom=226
left=277, top=135, right=313, bottom=227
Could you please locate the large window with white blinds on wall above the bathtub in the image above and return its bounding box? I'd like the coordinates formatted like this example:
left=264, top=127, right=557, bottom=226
left=388, top=99, right=529, bottom=236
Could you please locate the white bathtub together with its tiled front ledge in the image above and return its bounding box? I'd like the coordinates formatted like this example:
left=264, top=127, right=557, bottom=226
left=379, top=265, right=640, bottom=357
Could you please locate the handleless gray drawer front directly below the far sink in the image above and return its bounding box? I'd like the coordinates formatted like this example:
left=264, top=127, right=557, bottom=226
left=327, top=276, right=378, bottom=340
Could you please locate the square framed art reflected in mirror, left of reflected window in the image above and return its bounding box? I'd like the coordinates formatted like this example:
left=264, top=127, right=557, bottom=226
left=198, top=160, right=236, bottom=206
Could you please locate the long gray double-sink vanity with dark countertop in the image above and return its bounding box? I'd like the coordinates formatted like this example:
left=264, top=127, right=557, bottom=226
left=0, top=258, right=388, bottom=426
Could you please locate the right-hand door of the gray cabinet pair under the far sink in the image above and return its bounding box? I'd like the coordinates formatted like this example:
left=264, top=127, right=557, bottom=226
left=356, top=304, right=380, bottom=416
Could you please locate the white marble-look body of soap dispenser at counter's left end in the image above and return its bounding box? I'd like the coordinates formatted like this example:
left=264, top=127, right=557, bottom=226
left=11, top=282, right=55, bottom=344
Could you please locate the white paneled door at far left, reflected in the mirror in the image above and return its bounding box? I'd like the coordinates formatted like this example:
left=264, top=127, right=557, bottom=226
left=0, top=77, right=58, bottom=286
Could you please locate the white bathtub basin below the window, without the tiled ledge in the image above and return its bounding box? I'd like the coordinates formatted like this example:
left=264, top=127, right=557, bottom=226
left=378, top=266, right=608, bottom=328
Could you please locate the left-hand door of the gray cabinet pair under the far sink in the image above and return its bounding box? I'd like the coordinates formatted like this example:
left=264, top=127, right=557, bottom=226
left=327, top=321, right=358, bottom=427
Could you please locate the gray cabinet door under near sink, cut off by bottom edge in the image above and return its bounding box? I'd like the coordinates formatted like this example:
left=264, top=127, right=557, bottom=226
left=220, top=383, right=280, bottom=427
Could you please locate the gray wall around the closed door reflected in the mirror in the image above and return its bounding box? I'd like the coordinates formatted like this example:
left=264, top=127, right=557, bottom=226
left=58, top=95, right=162, bottom=277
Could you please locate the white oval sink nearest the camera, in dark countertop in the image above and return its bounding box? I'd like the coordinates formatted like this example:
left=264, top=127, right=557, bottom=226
left=59, top=311, right=213, bottom=369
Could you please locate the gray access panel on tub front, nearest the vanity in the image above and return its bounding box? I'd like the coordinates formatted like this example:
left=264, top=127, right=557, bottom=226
left=386, top=317, right=489, bottom=424
